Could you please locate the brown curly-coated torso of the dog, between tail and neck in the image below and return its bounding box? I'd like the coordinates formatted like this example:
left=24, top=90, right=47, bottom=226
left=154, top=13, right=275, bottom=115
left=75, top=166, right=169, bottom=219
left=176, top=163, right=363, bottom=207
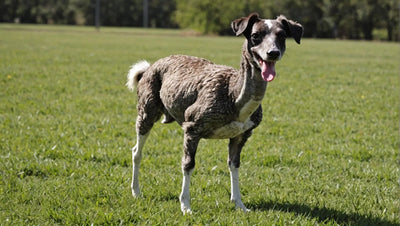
left=137, top=55, right=238, bottom=130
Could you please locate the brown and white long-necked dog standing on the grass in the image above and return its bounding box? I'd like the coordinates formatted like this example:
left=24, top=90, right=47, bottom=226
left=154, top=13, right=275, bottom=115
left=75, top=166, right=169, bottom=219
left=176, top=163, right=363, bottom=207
left=126, top=13, right=303, bottom=214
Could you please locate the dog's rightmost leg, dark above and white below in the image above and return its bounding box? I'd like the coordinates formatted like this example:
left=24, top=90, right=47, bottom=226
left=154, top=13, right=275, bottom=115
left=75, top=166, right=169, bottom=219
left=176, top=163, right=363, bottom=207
left=228, top=130, right=251, bottom=212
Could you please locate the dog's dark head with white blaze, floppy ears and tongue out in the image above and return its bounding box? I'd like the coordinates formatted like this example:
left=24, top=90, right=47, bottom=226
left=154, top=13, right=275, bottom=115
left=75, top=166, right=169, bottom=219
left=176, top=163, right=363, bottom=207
left=231, top=13, right=303, bottom=82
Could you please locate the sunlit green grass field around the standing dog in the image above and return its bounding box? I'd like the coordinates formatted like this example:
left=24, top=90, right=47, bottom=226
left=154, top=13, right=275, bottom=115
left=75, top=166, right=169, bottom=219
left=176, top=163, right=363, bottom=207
left=0, top=24, right=400, bottom=225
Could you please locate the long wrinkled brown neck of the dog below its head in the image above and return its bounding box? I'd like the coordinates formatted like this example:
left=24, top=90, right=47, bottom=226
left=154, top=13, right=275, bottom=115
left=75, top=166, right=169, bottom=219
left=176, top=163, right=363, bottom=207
left=234, top=40, right=267, bottom=110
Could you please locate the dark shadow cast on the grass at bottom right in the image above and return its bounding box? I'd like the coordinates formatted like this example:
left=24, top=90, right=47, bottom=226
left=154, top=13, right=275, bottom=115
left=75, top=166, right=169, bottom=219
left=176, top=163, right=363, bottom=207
left=247, top=200, right=399, bottom=225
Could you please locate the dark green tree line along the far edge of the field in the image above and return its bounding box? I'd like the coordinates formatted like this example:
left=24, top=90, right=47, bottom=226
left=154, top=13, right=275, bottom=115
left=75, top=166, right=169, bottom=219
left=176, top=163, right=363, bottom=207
left=0, top=0, right=400, bottom=41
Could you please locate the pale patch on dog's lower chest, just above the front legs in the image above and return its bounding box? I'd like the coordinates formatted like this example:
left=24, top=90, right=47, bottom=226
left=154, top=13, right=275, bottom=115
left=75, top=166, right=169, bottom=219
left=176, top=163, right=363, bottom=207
left=209, top=119, right=254, bottom=139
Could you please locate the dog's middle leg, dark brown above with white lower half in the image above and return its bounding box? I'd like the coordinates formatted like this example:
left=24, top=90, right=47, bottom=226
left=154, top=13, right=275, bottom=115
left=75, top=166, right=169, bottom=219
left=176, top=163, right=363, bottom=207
left=179, top=127, right=200, bottom=214
